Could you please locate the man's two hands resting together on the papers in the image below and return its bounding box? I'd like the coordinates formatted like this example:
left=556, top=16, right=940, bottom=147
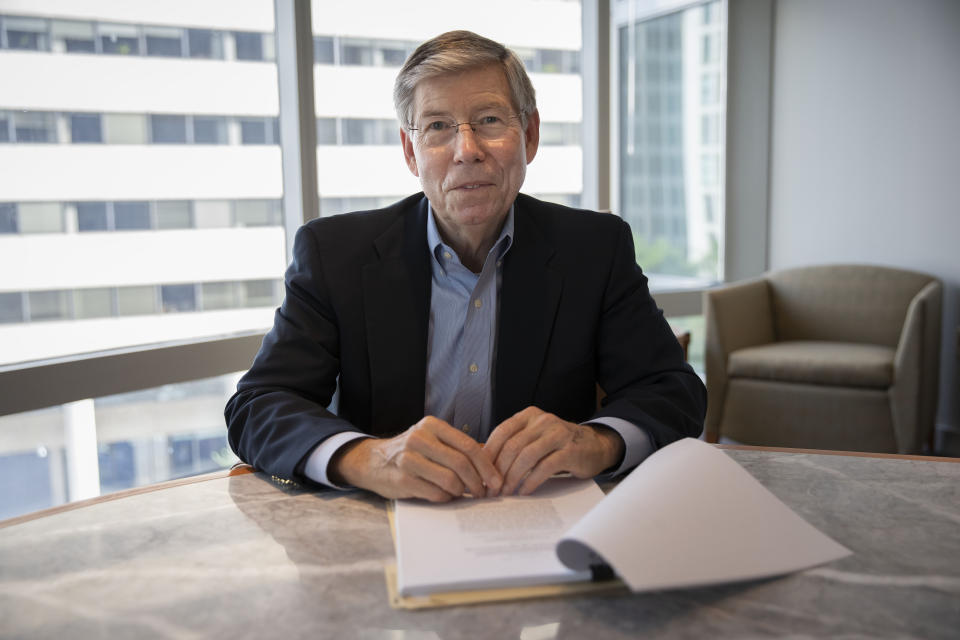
left=330, top=407, right=624, bottom=502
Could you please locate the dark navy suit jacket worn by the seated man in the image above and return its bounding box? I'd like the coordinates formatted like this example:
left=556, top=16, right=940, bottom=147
left=225, top=193, right=706, bottom=481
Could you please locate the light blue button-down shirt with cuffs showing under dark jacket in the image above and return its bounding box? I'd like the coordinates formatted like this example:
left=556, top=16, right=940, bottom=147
left=304, top=206, right=653, bottom=489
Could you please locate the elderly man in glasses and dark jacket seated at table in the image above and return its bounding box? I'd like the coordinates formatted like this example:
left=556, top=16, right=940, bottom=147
left=225, top=31, right=706, bottom=501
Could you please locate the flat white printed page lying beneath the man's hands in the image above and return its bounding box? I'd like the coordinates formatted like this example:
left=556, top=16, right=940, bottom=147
left=395, top=478, right=604, bottom=596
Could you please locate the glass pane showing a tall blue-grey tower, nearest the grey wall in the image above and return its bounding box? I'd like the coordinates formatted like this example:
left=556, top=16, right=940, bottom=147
left=614, top=0, right=724, bottom=287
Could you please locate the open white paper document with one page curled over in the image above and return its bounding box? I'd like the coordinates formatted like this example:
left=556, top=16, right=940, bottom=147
left=396, top=438, right=850, bottom=596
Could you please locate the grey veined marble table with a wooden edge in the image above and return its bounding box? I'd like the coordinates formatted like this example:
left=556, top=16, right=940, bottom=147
left=0, top=448, right=960, bottom=640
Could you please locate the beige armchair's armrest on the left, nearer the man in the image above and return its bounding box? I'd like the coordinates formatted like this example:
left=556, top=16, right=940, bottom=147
left=703, top=278, right=774, bottom=442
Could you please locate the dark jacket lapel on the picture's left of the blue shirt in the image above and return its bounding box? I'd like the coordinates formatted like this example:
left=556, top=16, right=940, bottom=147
left=362, top=198, right=430, bottom=432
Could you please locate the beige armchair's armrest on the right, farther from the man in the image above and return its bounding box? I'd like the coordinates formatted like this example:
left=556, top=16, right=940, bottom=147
left=890, top=280, right=943, bottom=453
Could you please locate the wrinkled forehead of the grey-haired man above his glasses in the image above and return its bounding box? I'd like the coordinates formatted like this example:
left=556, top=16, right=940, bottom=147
left=412, top=65, right=513, bottom=118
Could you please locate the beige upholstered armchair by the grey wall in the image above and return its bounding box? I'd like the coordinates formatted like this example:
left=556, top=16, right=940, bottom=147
left=704, top=265, right=943, bottom=453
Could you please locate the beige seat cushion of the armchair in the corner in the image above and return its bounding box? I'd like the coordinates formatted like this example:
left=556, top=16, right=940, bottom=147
left=727, top=340, right=895, bottom=389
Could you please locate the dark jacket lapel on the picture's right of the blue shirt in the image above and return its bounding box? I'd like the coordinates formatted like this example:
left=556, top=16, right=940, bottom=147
left=493, top=196, right=563, bottom=426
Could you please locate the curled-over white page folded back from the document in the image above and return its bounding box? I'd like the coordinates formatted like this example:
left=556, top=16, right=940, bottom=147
left=557, top=438, right=850, bottom=591
